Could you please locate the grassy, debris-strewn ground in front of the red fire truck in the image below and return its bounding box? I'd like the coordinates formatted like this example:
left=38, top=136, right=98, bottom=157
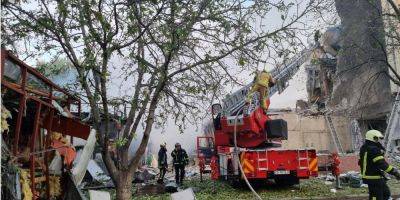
left=128, top=177, right=400, bottom=200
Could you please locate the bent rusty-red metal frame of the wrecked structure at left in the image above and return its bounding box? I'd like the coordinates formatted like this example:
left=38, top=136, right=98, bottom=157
left=1, top=49, right=90, bottom=199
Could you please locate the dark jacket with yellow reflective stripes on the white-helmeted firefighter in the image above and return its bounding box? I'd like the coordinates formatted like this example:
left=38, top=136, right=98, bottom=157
left=359, top=140, right=395, bottom=184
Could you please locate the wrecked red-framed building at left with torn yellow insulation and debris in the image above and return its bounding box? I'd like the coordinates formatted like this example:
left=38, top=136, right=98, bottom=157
left=1, top=49, right=90, bottom=199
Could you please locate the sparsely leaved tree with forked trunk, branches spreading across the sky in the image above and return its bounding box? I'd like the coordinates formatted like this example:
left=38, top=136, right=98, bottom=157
left=2, top=0, right=327, bottom=199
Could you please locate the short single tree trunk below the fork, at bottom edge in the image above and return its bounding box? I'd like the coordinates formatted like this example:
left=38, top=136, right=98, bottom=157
left=115, top=171, right=133, bottom=200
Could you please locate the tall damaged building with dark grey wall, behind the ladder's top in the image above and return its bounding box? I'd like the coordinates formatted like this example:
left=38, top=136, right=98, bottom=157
left=294, top=0, right=400, bottom=153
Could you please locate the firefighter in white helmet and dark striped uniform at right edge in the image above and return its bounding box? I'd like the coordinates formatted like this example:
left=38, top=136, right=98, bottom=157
left=359, top=130, right=400, bottom=200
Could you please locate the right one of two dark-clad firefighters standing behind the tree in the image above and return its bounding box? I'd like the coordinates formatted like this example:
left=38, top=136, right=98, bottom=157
left=171, top=143, right=189, bottom=185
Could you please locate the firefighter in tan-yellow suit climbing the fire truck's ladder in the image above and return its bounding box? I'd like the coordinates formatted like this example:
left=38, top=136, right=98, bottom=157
left=246, top=70, right=276, bottom=113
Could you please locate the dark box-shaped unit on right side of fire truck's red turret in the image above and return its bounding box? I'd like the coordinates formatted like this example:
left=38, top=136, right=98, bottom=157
left=265, top=119, right=288, bottom=140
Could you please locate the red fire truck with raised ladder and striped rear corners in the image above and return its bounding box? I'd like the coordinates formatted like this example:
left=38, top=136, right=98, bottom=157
left=197, top=48, right=318, bottom=185
